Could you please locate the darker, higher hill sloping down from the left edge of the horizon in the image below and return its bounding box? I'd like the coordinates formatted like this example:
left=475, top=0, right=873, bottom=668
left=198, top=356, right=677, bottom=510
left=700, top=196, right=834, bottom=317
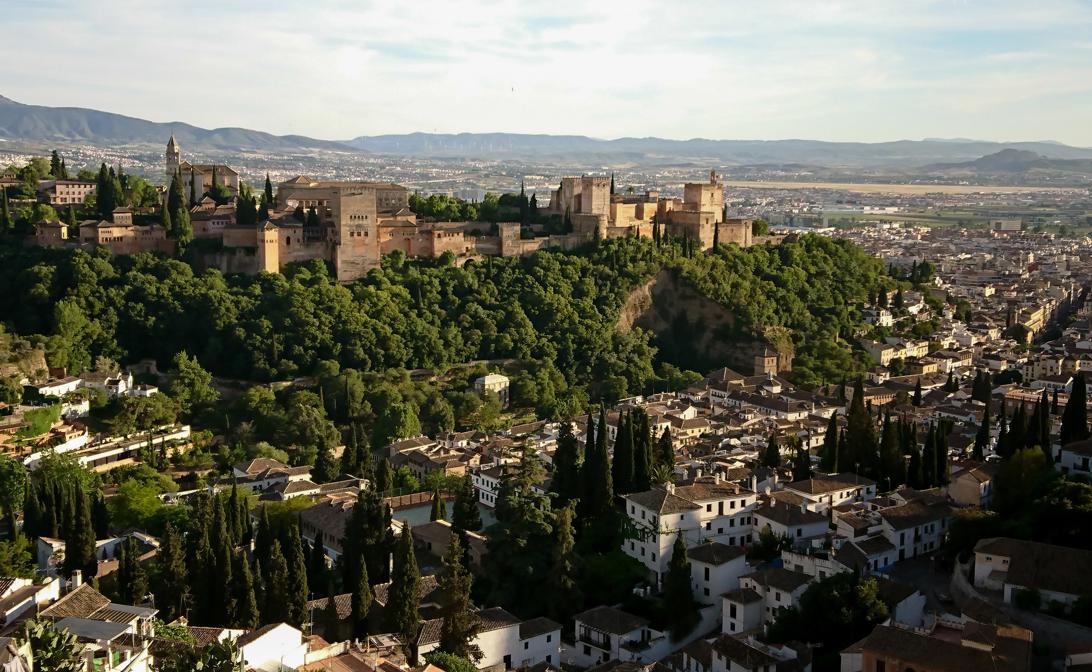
left=0, top=96, right=358, bottom=152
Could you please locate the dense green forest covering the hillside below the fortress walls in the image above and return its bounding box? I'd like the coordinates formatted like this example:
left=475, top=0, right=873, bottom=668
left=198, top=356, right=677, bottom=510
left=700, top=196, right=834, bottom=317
left=0, top=236, right=892, bottom=399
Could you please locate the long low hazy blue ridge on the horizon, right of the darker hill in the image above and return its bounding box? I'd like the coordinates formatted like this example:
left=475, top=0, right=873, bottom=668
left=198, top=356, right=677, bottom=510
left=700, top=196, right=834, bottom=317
left=345, top=133, right=1092, bottom=169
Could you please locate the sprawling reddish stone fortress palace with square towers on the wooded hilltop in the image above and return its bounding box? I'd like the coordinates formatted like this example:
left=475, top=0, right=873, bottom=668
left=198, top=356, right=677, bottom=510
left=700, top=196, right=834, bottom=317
left=36, top=137, right=751, bottom=282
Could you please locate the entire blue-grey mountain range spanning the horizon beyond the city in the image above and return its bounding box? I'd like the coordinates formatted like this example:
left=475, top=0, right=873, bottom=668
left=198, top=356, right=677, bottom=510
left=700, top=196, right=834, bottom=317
left=0, top=96, right=1092, bottom=173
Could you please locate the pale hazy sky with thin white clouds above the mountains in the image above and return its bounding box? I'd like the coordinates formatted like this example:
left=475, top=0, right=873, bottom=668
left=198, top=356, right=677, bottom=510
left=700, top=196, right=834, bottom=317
left=6, top=0, right=1092, bottom=145
